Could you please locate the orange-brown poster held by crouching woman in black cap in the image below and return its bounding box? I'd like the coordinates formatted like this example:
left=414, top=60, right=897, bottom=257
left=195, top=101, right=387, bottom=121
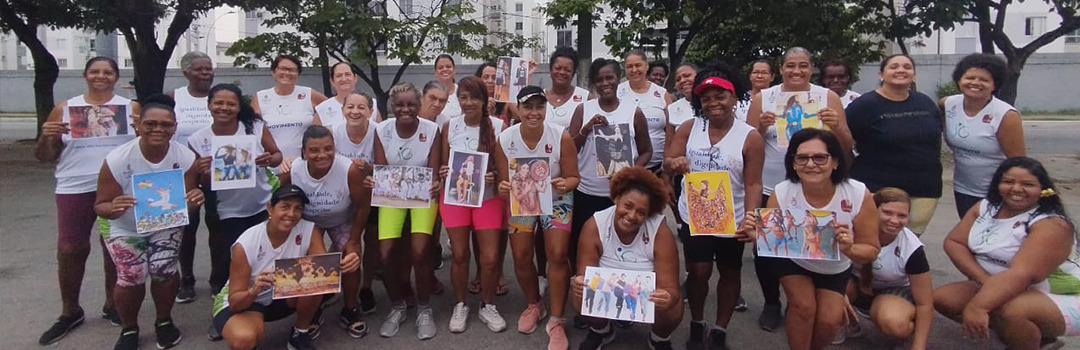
left=273, top=253, right=341, bottom=299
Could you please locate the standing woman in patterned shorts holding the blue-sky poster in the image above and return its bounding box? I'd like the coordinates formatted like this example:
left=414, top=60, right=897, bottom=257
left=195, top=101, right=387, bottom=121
left=94, top=94, right=203, bottom=350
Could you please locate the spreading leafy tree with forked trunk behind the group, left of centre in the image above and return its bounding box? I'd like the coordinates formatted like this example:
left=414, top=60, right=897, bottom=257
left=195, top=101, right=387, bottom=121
left=227, top=0, right=536, bottom=116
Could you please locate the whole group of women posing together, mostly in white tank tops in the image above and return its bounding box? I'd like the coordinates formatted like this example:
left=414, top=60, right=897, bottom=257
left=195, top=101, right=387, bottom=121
left=36, top=48, right=1080, bottom=350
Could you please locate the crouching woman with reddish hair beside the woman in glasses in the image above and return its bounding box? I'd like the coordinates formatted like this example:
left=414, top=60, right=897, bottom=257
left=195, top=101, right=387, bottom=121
left=833, top=187, right=934, bottom=349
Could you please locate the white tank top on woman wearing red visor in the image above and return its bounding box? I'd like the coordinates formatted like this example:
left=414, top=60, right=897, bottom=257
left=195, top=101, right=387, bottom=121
left=678, top=118, right=755, bottom=225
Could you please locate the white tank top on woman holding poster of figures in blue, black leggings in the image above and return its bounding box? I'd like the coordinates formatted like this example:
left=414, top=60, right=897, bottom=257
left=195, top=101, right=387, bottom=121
left=188, top=121, right=276, bottom=219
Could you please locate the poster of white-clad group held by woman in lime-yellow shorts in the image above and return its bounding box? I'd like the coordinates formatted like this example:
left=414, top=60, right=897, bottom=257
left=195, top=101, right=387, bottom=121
left=372, top=165, right=432, bottom=207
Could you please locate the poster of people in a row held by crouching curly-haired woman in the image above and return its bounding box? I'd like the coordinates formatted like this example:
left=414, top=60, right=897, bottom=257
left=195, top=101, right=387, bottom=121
left=581, top=266, right=657, bottom=323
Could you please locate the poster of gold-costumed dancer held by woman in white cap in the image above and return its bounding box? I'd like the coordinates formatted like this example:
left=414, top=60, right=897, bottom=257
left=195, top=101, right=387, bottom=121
left=509, top=157, right=553, bottom=216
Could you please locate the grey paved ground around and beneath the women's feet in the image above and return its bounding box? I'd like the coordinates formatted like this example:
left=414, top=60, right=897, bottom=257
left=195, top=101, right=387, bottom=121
left=0, top=129, right=1080, bottom=350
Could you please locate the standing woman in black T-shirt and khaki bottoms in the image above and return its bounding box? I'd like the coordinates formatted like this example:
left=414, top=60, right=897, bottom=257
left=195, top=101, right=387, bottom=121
left=847, top=54, right=941, bottom=235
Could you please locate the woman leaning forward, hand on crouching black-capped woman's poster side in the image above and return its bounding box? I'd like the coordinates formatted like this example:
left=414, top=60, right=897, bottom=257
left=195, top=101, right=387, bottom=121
left=281, top=125, right=372, bottom=339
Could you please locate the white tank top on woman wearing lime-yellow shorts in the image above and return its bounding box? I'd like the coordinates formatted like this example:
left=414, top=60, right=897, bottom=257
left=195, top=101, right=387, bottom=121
left=375, top=118, right=438, bottom=166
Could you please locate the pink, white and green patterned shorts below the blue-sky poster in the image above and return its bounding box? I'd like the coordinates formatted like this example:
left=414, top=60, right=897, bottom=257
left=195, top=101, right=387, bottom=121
left=105, top=227, right=184, bottom=287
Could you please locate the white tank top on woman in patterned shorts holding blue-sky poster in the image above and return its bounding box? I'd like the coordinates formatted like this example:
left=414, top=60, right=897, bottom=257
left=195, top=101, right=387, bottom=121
left=105, top=137, right=195, bottom=238
